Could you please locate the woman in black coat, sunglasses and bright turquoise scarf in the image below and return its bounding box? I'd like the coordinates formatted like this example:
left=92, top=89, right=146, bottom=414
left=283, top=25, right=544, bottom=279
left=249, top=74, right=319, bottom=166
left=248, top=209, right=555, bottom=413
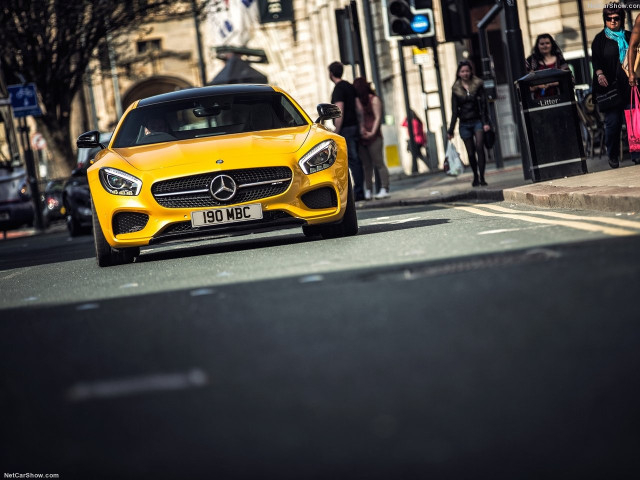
left=591, top=3, right=640, bottom=168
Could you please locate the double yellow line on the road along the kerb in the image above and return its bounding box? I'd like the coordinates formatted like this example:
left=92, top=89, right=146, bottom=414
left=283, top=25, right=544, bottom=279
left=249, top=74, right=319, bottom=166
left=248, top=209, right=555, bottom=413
left=453, top=204, right=640, bottom=236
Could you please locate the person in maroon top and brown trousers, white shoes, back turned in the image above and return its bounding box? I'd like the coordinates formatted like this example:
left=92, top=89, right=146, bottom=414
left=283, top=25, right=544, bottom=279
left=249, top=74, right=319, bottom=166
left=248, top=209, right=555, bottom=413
left=353, top=77, right=389, bottom=200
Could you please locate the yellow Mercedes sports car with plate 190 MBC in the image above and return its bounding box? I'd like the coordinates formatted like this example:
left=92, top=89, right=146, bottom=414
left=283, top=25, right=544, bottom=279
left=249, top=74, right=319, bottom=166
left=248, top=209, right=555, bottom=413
left=77, top=85, right=358, bottom=266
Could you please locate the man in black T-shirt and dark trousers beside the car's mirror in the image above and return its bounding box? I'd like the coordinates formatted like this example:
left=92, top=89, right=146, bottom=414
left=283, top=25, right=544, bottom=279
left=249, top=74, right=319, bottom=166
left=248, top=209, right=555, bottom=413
left=329, top=62, right=364, bottom=201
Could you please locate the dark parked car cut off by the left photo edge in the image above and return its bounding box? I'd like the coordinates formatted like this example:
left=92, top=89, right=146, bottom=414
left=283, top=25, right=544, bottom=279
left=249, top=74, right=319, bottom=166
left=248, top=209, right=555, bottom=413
left=0, top=162, right=35, bottom=232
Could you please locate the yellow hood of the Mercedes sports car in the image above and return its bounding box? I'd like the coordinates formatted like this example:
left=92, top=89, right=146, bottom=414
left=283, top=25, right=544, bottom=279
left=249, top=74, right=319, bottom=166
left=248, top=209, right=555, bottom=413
left=114, top=127, right=309, bottom=171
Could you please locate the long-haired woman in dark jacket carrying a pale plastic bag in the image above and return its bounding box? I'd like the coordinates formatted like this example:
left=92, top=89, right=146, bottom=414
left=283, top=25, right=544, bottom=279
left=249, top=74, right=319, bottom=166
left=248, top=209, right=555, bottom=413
left=447, top=60, right=491, bottom=187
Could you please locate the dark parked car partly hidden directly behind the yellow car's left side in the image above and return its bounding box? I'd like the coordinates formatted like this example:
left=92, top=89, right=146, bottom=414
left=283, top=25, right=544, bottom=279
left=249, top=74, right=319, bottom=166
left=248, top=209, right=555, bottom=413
left=63, top=133, right=111, bottom=237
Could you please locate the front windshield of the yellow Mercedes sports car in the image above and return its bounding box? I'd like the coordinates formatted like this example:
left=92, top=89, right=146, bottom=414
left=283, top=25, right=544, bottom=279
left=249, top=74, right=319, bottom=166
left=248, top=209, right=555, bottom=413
left=113, top=92, right=308, bottom=148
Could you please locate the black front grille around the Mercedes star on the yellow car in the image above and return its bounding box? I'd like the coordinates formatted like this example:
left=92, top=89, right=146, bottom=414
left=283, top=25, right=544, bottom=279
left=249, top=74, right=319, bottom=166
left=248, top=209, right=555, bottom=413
left=151, top=167, right=292, bottom=208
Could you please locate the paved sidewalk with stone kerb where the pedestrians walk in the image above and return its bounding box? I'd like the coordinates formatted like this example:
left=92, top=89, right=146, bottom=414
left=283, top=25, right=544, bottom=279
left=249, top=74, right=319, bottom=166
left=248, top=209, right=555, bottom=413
left=357, top=157, right=640, bottom=213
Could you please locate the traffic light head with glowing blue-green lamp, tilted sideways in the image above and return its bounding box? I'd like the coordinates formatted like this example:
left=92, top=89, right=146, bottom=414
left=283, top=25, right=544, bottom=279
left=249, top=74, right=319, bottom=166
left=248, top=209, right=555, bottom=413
left=383, top=0, right=436, bottom=40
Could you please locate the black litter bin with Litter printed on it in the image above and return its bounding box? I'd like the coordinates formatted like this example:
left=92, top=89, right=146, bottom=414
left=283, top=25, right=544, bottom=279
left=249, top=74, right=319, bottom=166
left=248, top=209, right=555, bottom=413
left=516, top=69, right=587, bottom=182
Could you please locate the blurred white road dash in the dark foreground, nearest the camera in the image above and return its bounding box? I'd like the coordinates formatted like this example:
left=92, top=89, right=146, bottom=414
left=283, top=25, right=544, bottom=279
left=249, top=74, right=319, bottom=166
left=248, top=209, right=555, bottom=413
left=67, top=368, right=209, bottom=402
